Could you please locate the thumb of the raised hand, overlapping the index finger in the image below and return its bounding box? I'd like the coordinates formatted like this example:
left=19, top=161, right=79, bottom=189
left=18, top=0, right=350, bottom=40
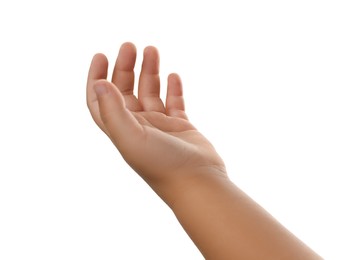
left=94, top=80, right=143, bottom=156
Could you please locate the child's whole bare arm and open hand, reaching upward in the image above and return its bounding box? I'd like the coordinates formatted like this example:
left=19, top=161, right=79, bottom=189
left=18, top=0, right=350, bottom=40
left=87, top=43, right=322, bottom=260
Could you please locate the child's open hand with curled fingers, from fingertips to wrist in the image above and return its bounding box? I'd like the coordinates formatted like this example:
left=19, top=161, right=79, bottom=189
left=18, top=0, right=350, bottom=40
left=87, top=43, right=226, bottom=201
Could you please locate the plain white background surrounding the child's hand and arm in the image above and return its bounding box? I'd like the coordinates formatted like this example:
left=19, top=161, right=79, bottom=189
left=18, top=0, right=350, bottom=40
left=0, top=0, right=364, bottom=260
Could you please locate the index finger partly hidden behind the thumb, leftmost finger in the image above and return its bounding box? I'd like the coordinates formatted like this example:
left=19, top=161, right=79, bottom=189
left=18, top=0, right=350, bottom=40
left=86, top=53, right=108, bottom=129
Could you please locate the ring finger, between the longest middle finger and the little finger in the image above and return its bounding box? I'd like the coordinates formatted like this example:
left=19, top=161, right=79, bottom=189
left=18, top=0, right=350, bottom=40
left=138, top=46, right=165, bottom=113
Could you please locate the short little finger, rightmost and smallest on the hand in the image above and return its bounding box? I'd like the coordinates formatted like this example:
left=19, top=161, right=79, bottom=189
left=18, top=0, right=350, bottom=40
left=166, top=73, right=187, bottom=119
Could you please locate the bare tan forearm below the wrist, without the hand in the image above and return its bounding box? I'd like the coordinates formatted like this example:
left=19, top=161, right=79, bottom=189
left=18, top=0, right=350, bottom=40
left=165, top=174, right=321, bottom=260
